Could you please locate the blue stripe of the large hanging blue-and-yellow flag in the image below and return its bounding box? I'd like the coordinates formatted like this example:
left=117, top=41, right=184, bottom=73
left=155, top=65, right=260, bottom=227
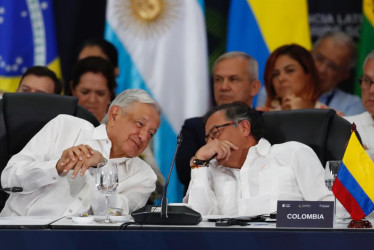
left=226, top=0, right=270, bottom=104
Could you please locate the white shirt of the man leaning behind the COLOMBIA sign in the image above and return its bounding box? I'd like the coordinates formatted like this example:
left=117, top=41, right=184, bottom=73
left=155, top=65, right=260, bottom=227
left=184, top=139, right=333, bottom=216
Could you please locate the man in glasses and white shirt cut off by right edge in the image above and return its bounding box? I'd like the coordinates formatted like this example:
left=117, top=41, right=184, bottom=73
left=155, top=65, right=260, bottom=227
left=345, top=50, right=374, bottom=161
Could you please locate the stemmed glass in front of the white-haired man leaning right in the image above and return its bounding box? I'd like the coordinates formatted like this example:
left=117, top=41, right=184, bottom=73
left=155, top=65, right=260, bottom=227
left=96, top=161, right=118, bottom=223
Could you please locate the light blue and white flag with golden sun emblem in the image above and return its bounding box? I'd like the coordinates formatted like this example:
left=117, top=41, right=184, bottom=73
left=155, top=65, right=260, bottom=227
left=105, top=0, right=209, bottom=202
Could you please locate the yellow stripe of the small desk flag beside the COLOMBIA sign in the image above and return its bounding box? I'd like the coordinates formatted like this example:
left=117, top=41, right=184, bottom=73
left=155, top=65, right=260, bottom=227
left=343, top=133, right=374, bottom=201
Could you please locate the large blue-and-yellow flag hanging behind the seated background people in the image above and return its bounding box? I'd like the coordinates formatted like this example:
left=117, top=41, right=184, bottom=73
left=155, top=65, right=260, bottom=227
left=227, top=0, right=312, bottom=106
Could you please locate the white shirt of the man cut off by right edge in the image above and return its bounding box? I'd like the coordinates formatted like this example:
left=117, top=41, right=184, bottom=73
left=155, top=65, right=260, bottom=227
left=344, top=112, right=374, bottom=161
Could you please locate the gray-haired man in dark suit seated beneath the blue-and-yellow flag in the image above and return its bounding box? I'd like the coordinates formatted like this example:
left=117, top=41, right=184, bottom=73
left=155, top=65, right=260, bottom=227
left=176, top=52, right=261, bottom=192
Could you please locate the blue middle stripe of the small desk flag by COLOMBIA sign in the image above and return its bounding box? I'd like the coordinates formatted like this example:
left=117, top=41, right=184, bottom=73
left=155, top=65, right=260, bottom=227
left=338, top=162, right=374, bottom=215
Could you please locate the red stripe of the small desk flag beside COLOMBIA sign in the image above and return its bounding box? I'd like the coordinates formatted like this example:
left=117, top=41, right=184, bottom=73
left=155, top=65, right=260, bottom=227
left=332, top=178, right=366, bottom=220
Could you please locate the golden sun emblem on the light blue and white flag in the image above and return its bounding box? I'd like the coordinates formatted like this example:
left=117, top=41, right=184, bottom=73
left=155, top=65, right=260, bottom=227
left=114, top=0, right=181, bottom=37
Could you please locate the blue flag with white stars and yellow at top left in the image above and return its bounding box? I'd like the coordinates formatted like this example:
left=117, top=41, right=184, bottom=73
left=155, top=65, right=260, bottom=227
left=0, top=0, right=61, bottom=92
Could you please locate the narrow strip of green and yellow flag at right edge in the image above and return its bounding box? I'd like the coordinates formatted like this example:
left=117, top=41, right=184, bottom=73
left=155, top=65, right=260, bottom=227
left=355, top=0, right=374, bottom=95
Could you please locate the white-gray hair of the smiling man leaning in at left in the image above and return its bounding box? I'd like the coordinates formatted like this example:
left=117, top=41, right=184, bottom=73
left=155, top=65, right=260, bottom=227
left=101, top=89, right=161, bottom=124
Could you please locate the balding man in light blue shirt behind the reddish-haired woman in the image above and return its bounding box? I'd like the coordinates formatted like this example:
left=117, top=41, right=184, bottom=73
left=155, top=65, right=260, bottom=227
left=312, top=32, right=364, bottom=115
